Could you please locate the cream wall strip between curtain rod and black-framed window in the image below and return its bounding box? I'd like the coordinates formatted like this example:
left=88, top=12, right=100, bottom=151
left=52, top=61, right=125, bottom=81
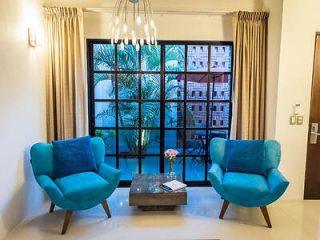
left=84, top=13, right=232, bottom=40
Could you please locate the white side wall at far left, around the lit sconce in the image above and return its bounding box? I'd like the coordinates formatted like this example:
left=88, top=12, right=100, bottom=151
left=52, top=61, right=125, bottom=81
left=0, top=0, right=46, bottom=239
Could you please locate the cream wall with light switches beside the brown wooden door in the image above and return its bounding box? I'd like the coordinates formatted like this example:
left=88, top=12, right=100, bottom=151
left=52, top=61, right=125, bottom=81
left=276, top=0, right=320, bottom=199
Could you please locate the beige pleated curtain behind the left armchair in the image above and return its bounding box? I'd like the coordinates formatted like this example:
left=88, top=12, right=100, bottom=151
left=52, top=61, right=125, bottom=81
left=45, top=8, right=87, bottom=141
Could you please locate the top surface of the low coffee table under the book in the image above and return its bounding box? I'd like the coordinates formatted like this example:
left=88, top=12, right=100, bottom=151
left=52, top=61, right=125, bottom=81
left=130, top=173, right=186, bottom=194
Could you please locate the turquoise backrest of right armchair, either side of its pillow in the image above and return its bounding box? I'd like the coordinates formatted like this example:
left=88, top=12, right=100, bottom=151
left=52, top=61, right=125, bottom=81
left=210, top=138, right=281, bottom=171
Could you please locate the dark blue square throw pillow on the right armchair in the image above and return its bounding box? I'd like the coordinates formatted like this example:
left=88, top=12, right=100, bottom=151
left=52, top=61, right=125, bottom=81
left=225, top=140, right=267, bottom=176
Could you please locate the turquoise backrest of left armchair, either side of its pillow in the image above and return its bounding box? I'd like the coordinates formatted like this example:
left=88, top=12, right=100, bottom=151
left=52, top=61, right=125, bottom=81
left=31, top=137, right=105, bottom=179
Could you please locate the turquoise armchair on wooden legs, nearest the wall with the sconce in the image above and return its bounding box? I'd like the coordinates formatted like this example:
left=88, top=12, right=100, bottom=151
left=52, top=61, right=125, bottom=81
left=31, top=137, right=121, bottom=234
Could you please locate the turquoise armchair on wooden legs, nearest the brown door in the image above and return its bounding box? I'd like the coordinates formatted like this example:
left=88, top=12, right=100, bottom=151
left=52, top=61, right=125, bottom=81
left=208, top=138, right=289, bottom=228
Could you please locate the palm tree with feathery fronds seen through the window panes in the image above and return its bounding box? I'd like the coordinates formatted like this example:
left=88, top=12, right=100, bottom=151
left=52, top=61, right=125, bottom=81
left=94, top=44, right=188, bottom=153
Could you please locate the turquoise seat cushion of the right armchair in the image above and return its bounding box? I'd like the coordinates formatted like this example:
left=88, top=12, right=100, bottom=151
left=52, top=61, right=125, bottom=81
left=222, top=172, right=270, bottom=200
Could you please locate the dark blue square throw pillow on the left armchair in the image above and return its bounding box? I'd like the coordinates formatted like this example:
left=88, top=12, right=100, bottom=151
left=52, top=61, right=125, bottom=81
left=52, top=136, right=97, bottom=178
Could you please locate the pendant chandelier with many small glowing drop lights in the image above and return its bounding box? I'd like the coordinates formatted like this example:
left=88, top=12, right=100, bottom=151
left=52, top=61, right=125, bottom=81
left=110, top=0, right=157, bottom=51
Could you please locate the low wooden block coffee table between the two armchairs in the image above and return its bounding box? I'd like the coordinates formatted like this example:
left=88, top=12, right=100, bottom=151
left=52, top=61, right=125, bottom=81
left=129, top=174, right=187, bottom=211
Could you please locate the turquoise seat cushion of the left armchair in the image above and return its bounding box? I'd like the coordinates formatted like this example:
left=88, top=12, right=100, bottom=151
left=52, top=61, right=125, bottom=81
left=55, top=172, right=110, bottom=202
